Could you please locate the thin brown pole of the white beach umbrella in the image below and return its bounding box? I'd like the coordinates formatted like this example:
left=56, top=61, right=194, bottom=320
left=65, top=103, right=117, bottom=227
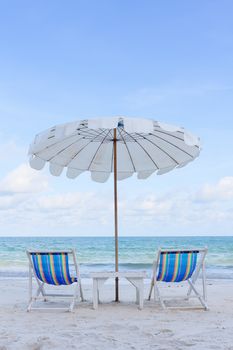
left=113, top=128, right=119, bottom=302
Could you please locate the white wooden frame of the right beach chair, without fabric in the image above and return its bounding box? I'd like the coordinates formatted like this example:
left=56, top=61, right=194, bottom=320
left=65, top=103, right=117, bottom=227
left=148, top=248, right=209, bottom=310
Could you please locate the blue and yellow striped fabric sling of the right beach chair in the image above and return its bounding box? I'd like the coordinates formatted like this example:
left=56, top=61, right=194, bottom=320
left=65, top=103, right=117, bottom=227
left=157, top=251, right=199, bottom=282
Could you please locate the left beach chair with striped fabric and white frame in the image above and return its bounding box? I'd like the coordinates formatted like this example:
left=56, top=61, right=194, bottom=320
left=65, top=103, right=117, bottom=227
left=27, top=250, right=83, bottom=311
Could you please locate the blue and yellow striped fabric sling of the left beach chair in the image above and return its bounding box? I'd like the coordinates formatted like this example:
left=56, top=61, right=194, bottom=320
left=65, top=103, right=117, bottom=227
left=28, top=251, right=77, bottom=285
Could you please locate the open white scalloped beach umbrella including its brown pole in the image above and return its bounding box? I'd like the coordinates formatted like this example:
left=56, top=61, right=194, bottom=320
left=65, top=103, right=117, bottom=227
left=29, top=117, right=200, bottom=301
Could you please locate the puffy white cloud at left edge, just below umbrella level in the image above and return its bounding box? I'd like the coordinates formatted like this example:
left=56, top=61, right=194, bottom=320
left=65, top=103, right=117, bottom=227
left=0, top=164, right=48, bottom=194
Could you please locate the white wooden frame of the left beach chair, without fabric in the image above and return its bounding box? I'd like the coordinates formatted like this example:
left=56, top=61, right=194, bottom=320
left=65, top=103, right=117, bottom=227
left=26, top=249, right=84, bottom=312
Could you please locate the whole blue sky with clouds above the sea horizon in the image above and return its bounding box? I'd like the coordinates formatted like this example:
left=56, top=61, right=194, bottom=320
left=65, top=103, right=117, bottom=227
left=0, top=0, right=233, bottom=236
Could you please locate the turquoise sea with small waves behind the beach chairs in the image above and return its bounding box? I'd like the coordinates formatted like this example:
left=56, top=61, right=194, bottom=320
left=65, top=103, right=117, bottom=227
left=0, top=237, right=233, bottom=279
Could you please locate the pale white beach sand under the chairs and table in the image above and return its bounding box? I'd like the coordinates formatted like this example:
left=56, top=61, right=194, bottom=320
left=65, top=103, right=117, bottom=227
left=0, top=278, right=233, bottom=350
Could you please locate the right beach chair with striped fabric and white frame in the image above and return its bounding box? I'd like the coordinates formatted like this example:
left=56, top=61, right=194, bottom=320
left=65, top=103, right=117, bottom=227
left=148, top=248, right=208, bottom=310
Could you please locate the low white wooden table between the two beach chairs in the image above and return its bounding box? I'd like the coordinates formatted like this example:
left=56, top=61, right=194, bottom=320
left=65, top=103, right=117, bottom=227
left=90, top=271, right=146, bottom=310
